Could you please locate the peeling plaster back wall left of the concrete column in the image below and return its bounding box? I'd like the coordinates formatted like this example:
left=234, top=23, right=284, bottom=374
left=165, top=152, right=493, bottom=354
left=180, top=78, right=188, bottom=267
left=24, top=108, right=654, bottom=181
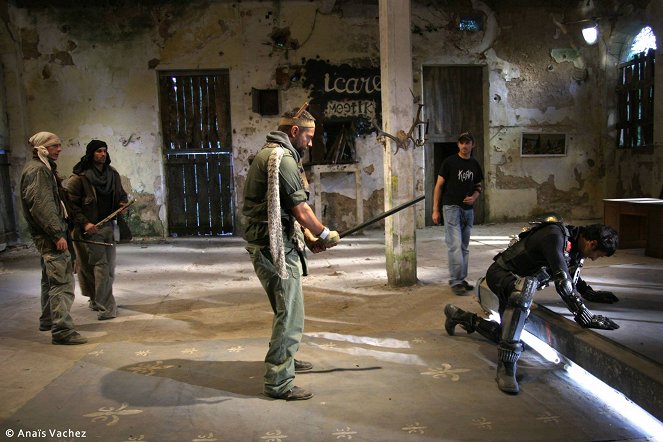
left=3, top=1, right=383, bottom=235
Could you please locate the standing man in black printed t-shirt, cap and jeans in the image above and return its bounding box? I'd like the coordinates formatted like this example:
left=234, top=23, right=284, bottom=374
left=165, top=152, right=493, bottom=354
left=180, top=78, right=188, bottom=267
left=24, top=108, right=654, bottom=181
left=433, top=132, right=483, bottom=296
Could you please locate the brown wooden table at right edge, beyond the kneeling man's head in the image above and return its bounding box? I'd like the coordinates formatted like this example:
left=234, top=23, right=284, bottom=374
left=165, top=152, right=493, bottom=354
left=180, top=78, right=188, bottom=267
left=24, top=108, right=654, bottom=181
left=603, top=198, right=663, bottom=258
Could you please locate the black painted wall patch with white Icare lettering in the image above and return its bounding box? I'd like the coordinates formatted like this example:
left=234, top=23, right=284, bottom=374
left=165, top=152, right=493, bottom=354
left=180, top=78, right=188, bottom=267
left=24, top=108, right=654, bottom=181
left=303, top=60, right=381, bottom=134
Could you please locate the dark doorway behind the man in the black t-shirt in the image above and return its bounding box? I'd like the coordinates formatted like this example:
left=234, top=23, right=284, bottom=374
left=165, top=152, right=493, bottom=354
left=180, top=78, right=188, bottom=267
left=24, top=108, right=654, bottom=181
left=423, top=66, right=487, bottom=226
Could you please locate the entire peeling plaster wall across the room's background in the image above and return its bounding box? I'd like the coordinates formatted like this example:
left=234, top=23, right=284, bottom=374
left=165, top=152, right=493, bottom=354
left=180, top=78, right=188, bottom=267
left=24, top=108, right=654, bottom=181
left=0, top=0, right=663, bottom=235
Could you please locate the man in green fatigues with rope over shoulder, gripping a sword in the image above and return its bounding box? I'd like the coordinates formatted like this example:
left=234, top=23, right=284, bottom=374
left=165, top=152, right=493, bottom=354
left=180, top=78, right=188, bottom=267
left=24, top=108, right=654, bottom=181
left=243, top=107, right=340, bottom=401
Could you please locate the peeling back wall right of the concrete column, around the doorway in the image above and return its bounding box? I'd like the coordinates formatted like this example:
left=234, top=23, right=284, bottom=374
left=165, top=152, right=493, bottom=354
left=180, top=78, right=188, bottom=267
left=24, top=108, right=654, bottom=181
left=416, top=1, right=620, bottom=221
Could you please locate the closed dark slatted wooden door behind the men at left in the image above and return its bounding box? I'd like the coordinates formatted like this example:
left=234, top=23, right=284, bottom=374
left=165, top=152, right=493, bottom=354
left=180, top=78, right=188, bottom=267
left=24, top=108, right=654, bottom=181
left=159, top=70, right=235, bottom=236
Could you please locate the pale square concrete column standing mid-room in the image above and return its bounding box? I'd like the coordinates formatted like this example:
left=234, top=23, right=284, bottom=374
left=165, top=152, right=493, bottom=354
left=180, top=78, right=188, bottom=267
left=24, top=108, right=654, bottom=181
left=380, top=0, right=417, bottom=287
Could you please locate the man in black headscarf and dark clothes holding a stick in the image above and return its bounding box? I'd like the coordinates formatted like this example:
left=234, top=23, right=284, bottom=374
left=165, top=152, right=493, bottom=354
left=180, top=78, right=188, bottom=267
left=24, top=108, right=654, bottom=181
left=65, top=140, right=127, bottom=321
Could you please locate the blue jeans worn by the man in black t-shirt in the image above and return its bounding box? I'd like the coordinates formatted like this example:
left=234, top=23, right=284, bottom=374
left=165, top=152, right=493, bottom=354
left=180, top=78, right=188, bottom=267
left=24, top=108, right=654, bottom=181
left=442, top=205, right=474, bottom=286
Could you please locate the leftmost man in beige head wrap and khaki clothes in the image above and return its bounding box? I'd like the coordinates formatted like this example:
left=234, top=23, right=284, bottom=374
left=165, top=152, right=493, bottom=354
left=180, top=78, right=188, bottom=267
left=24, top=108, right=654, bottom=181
left=21, top=132, right=87, bottom=345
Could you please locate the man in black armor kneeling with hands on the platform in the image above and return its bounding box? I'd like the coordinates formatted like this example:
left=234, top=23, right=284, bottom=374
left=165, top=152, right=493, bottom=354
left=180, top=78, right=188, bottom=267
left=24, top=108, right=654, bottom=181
left=444, top=222, right=619, bottom=394
